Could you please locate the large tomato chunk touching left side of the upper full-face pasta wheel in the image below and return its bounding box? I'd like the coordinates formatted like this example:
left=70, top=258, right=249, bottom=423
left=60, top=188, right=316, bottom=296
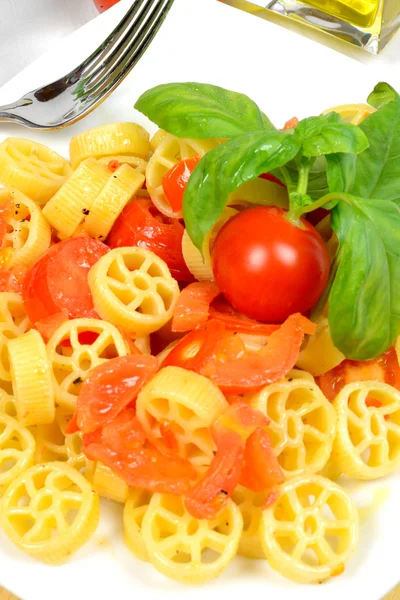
left=22, top=236, right=108, bottom=323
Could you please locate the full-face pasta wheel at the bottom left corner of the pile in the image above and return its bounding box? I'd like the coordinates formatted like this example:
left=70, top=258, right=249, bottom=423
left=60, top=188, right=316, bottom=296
left=1, top=462, right=100, bottom=565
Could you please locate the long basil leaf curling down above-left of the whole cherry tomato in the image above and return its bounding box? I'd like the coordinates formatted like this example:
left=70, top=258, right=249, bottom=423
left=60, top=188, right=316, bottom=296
left=183, top=131, right=300, bottom=251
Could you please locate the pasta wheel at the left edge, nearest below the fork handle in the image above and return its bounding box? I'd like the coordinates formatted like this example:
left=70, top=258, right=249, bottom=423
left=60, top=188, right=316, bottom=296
left=0, top=138, right=72, bottom=205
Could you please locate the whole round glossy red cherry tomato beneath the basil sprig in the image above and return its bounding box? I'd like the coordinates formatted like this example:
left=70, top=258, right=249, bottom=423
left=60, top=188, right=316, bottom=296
left=213, top=206, right=330, bottom=323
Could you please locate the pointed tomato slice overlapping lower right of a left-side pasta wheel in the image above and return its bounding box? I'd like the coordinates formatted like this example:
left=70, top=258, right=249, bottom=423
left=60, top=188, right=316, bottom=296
left=76, top=354, right=158, bottom=433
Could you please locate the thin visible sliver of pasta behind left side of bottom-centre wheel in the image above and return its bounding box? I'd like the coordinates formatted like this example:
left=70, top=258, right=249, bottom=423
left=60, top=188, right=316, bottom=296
left=123, top=489, right=152, bottom=562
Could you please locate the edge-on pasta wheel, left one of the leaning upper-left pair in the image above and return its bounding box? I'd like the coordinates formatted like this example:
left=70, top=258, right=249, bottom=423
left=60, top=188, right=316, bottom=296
left=43, top=158, right=112, bottom=238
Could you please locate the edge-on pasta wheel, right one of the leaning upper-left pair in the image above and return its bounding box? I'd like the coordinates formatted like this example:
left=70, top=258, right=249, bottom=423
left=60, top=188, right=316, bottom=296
left=84, top=165, right=144, bottom=240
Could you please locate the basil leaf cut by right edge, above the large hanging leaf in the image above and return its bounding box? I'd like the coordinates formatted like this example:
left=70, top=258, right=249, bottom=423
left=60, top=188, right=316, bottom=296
left=351, top=100, right=400, bottom=200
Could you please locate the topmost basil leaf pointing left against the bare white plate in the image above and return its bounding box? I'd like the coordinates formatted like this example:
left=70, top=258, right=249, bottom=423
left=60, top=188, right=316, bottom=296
left=135, top=83, right=275, bottom=139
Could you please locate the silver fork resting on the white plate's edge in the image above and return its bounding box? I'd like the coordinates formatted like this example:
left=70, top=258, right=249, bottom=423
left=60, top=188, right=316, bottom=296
left=0, top=0, right=174, bottom=130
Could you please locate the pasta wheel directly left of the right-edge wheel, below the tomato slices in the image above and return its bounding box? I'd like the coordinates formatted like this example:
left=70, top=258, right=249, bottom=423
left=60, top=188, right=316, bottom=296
left=250, top=377, right=336, bottom=477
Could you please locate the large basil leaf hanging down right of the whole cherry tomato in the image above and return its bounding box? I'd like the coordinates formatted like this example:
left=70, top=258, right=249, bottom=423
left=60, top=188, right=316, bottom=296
left=329, top=196, right=400, bottom=360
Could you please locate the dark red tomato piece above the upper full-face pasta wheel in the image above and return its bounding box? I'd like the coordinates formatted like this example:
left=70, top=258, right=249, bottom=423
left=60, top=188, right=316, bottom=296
left=107, top=198, right=193, bottom=281
